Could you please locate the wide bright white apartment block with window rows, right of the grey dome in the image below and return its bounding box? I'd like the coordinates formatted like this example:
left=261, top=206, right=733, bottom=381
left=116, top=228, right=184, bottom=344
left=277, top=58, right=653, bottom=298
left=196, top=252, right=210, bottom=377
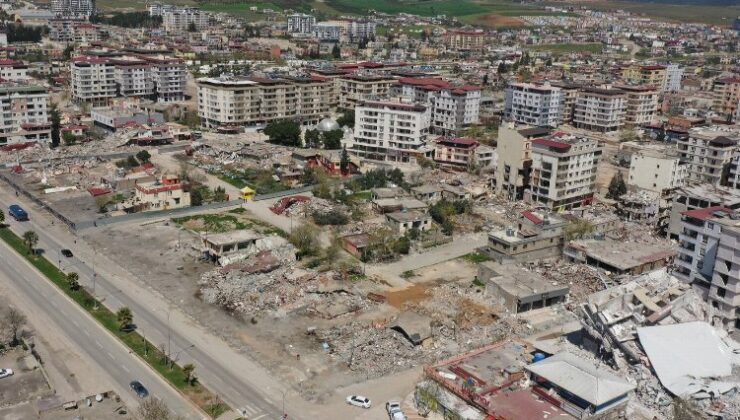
left=348, top=101, right=431, bottom=163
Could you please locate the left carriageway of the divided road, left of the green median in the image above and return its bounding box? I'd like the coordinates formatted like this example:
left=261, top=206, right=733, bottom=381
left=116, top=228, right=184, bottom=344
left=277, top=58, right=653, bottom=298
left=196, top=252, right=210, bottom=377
left=0, top=222, right=202, bottom=419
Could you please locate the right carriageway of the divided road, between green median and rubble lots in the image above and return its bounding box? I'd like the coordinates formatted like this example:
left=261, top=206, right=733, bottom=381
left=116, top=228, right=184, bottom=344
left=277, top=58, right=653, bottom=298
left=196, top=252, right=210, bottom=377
left=0, top=194, right=292, bottom=420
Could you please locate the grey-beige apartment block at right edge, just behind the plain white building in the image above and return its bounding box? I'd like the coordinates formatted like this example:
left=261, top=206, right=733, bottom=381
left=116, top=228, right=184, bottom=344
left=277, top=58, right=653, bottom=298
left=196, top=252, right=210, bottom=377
left=677, top=127, right=740, bottom=185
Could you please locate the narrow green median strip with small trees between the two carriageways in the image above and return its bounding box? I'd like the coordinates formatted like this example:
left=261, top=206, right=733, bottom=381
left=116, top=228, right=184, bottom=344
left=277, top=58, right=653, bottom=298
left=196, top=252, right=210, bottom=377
left=0, top=227, right=229, bottom=418
